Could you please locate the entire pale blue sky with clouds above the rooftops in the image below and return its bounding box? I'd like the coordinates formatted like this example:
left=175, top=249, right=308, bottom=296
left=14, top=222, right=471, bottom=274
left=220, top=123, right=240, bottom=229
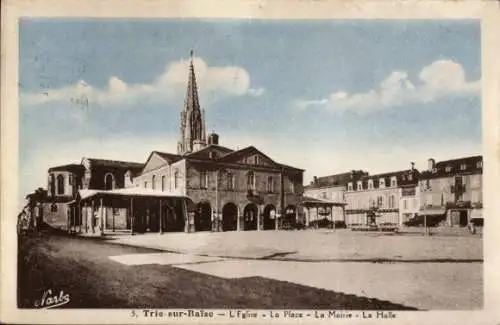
left=19, top=19, right=482, bottom=200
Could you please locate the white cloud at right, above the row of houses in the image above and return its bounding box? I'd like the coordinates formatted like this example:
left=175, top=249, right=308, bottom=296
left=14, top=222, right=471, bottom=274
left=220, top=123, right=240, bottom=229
left=293, top=60, right=481, bottom=115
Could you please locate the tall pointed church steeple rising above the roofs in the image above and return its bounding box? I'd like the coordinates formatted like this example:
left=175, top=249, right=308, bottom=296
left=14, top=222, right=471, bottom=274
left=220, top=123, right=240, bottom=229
left=177, top=50, right=206, bottom=155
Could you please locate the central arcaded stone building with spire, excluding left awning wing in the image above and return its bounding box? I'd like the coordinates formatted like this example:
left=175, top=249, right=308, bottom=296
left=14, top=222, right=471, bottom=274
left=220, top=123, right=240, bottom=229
left=133, top=52, right=304, bottom=231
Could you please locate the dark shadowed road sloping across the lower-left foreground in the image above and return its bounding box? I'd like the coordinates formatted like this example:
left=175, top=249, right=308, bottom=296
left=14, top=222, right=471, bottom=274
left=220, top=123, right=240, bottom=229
left=18, top=235, right=416, bottom=310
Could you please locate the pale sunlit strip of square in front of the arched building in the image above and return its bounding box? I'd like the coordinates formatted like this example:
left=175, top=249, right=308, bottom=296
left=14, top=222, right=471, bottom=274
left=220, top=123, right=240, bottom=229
left=107, top=228, right=483, bottom=262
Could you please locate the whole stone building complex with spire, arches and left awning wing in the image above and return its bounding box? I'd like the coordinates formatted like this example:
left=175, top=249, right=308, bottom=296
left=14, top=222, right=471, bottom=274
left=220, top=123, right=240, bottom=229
left=40, top=52, right=304, bottom=234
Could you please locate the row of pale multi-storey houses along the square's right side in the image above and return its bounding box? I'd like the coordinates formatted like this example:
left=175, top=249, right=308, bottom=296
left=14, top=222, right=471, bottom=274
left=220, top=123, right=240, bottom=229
left=304, top=156, right=483, bottom=227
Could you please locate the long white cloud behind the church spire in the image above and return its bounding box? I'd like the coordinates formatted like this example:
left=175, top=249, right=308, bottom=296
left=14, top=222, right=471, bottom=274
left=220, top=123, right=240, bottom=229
left=21, top=58, right=264, bottom=107
